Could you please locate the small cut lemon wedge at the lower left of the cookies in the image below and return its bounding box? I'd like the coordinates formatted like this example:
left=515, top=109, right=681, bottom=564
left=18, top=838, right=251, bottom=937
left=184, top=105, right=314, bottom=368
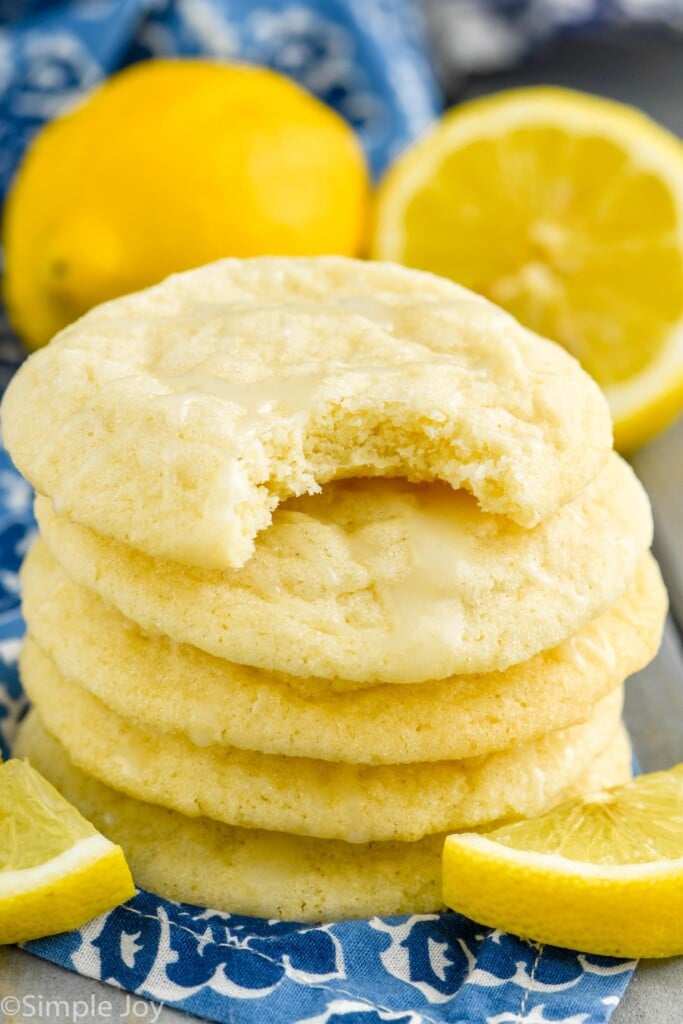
left=0, top=761, right=135, bottom=943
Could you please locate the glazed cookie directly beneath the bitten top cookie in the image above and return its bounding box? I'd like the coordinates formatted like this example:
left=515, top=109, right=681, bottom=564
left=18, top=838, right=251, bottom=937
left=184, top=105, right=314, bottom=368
left=36, top=455, right=652, bottom=685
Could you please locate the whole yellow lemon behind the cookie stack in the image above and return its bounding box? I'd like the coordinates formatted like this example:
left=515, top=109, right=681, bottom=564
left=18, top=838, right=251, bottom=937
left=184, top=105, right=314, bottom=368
left=4, top=59, right=369, bottom=348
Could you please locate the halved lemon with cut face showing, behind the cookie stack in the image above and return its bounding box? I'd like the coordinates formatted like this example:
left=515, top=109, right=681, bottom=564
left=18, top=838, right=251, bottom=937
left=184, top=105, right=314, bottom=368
left=373, top=88, right=683, bottom=451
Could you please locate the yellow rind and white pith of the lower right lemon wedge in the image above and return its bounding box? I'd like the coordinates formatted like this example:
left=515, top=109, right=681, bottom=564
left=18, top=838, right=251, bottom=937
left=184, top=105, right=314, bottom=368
left=443, top=834, right=683, bottom=959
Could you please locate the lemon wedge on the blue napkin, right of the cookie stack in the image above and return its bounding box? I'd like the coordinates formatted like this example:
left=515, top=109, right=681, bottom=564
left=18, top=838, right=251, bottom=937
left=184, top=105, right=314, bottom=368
left=443, top=764, right=683, bottom=957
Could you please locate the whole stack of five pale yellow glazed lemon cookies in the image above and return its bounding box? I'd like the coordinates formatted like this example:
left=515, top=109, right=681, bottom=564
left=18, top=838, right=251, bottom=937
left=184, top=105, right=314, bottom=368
left=3, top=257, right=666, bottom=921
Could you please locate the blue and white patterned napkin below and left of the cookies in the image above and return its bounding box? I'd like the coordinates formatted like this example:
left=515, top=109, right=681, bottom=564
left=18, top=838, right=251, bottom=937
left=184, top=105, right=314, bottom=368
left=0, top=323, right=635, bottom=1024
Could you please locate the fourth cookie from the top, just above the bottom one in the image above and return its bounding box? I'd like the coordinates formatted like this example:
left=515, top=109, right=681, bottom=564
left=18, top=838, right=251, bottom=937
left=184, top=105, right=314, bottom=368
left=19, top=636, right=624, bottom=843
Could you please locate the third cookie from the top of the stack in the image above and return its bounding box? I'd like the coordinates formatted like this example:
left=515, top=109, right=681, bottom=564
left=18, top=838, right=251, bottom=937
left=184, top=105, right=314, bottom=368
left=22, top=542, right=667, bottom=764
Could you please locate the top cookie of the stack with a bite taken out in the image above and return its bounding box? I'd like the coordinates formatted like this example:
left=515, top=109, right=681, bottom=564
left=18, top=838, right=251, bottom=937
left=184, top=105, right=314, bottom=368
left=3, top=251, right=611, bottom=568
